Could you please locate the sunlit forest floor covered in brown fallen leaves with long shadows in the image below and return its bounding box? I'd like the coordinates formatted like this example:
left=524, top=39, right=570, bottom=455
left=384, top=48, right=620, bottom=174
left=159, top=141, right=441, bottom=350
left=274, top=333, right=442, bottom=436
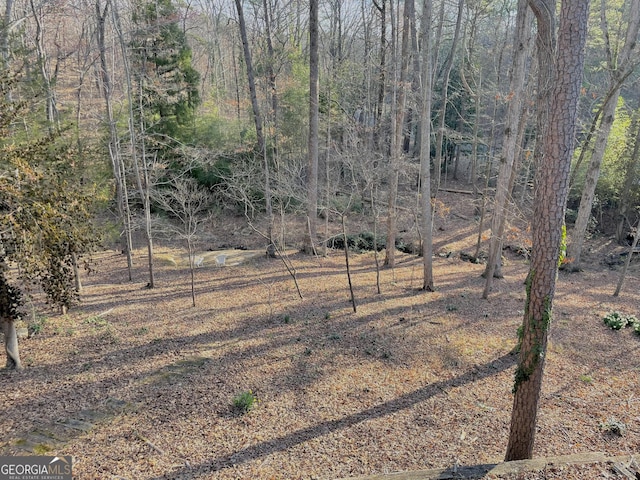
left=0, top=188, right=640, bottom=480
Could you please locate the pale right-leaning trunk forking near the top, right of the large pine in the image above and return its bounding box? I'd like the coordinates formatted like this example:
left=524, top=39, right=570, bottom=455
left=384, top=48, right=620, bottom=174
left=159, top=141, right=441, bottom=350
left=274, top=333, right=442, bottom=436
left=567, top=1, right=640, bottom=270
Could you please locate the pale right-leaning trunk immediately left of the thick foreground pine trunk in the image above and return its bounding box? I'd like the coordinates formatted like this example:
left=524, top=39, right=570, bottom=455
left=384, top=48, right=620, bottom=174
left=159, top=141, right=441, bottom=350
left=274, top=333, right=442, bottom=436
left=482, top=0, right=533, bottom=299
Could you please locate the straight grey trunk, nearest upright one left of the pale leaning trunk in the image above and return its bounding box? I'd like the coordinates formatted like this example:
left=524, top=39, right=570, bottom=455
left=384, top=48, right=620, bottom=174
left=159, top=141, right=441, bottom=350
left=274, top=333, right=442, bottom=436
left=420, top=0, right=434, bottom=292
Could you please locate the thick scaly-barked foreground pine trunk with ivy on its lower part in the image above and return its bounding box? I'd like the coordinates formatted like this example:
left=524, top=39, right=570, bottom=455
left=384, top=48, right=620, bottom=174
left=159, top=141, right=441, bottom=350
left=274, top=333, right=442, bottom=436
left=505, top=0, right=589, bottom=461
